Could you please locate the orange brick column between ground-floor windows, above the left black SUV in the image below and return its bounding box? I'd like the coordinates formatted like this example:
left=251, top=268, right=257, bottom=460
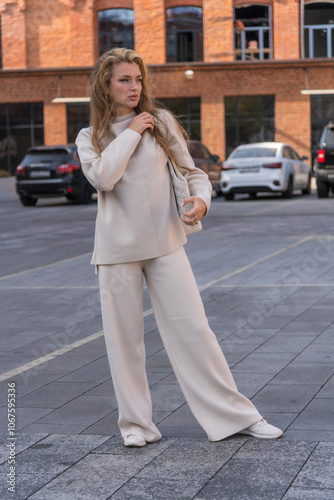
left=44, top=104, right=67, bottom=146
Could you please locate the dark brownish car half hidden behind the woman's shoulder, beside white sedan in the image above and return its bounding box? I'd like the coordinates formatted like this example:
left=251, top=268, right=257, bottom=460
left=188, top=141, right=223, bottom=195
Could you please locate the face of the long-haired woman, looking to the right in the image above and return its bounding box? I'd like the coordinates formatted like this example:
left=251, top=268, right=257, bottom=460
left=110, top=62, right=142, bottom=116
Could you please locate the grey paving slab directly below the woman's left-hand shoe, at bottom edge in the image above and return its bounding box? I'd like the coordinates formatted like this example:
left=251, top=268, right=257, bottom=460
left=27, top=439, right=174, bottom=500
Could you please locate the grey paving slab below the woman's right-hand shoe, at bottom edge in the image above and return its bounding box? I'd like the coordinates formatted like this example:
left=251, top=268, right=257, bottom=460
left=195, top=440, right=316, bottom=500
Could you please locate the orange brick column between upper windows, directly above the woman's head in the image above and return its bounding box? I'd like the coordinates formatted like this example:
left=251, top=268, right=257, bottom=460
left=133, top=0, right=166, bottom=64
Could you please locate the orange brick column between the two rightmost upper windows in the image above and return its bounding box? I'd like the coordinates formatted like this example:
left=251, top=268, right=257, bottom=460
left=272, top=0, right=300, bottom=59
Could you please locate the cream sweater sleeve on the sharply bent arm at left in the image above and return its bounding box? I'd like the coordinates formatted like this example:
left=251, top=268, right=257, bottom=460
left=75, top=128, right=141, bottom=191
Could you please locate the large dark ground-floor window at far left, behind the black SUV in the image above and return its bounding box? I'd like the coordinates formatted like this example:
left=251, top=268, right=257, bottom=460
left=0, top=102, right=44, bottom=175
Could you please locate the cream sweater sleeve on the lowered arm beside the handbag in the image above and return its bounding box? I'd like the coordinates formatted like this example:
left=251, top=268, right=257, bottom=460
left=161, top=111, right=212, bottom=214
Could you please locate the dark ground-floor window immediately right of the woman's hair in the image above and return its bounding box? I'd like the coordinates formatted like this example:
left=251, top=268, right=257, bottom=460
left=159, top=97, right=201, bottom=141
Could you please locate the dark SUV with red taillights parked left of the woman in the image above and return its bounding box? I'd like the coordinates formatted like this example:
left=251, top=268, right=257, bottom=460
left=16, top=144, right=95, bottom=206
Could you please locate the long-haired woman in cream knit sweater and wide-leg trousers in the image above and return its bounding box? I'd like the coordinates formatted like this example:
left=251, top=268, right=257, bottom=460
left=76, top=49, right=282, bottom=446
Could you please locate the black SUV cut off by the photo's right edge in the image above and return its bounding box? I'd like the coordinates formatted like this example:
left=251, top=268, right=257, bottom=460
left=313, top=122, right=334, bottom=198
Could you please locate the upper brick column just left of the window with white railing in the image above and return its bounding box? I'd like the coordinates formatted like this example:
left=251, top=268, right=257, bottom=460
left=203, top=0, right=234, bottom=62
